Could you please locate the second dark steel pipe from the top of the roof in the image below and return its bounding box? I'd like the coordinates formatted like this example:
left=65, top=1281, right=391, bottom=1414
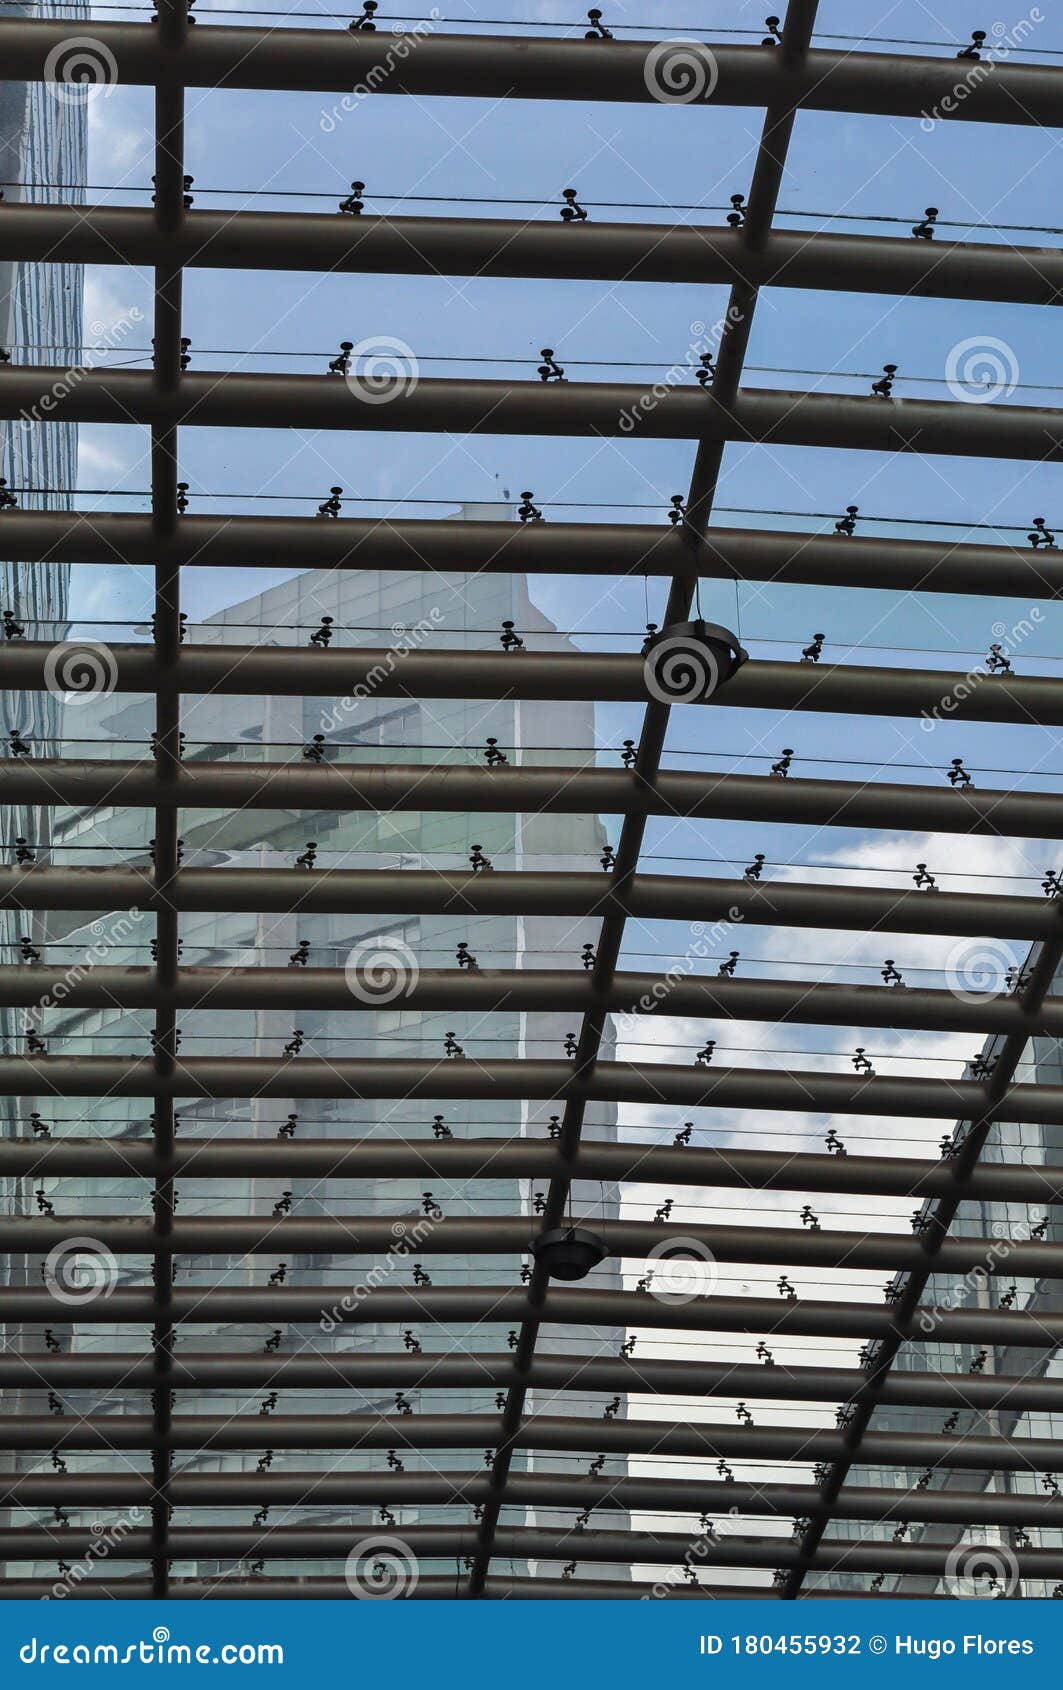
left=0, top=204, right=1063, bottom=306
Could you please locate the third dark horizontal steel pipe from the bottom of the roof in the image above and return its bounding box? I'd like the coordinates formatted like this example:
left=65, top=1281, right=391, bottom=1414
left=0, top=1467, right=1061, bottom=1531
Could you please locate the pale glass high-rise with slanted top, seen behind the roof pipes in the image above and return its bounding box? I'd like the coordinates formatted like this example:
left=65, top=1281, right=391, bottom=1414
left=2, top=505, right=629, bottom=1578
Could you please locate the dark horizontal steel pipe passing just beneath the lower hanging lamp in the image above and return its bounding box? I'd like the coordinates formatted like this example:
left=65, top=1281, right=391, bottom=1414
left=3, top=1284, right=1063, bottom=1338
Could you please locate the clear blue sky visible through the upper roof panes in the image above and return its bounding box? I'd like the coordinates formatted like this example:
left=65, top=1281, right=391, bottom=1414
left=74, top=0, right=1063, bottom=912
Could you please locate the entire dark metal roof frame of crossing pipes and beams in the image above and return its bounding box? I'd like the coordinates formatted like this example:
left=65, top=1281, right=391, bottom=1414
left=0, top=0, right=1063, bottom=1599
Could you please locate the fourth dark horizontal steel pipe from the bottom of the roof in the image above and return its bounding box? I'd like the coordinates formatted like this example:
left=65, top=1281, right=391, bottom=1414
left=12, top=1413, right=1063, bottom=1480
